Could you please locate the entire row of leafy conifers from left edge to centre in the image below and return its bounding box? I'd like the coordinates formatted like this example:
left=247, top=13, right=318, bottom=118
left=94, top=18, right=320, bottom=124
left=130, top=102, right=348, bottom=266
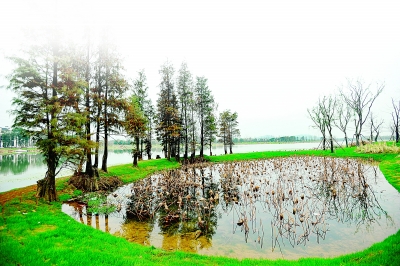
left=8, top=33, right=239, bottom=201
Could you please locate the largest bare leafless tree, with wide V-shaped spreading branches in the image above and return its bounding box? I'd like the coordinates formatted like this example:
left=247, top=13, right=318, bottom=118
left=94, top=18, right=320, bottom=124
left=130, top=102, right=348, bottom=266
left=340, top=80, right=385, bottom=146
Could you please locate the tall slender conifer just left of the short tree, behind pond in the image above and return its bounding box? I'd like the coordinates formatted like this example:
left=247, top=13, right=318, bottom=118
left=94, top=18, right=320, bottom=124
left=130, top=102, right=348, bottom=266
left=195, top=77, right=215, bottom=157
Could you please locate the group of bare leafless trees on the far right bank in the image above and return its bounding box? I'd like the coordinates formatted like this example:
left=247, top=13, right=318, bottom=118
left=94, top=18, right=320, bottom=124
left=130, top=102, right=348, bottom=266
left=307, top=80, right=400, bottom=152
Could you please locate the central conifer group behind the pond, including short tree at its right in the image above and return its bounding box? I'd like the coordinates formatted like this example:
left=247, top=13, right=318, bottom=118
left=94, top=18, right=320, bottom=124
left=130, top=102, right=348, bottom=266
left=155, top=62, right=240, bottom=161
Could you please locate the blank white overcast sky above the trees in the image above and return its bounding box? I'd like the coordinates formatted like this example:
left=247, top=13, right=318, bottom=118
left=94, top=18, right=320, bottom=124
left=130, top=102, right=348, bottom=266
left=0, top=0, right=400, bottom=137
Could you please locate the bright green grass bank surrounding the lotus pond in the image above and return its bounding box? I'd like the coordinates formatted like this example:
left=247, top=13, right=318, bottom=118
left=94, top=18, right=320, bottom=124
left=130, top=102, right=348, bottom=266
left=0, top=148, right=400, bottom=265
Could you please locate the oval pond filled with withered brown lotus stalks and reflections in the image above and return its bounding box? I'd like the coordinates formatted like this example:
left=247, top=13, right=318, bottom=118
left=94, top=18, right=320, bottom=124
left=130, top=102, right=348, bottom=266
left=62, top=157, right=400, bottom=259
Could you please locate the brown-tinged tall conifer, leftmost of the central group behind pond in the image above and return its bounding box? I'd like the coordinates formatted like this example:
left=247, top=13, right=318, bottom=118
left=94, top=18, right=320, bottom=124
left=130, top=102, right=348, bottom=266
left=156, top=62, right=180, bottom=160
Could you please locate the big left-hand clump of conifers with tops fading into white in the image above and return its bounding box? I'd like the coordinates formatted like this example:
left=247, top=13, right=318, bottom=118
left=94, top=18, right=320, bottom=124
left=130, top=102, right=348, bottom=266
left=9, top=33, right=145, bottom=201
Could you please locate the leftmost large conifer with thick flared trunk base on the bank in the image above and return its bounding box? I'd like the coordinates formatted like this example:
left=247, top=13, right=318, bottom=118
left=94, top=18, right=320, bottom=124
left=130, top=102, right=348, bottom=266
left=9, top=39, right=87, bottom=201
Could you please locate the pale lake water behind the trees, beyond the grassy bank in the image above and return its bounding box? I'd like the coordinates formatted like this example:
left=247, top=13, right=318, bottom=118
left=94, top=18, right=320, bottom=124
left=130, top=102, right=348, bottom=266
left=0, top=142, right=318, bottom=192
